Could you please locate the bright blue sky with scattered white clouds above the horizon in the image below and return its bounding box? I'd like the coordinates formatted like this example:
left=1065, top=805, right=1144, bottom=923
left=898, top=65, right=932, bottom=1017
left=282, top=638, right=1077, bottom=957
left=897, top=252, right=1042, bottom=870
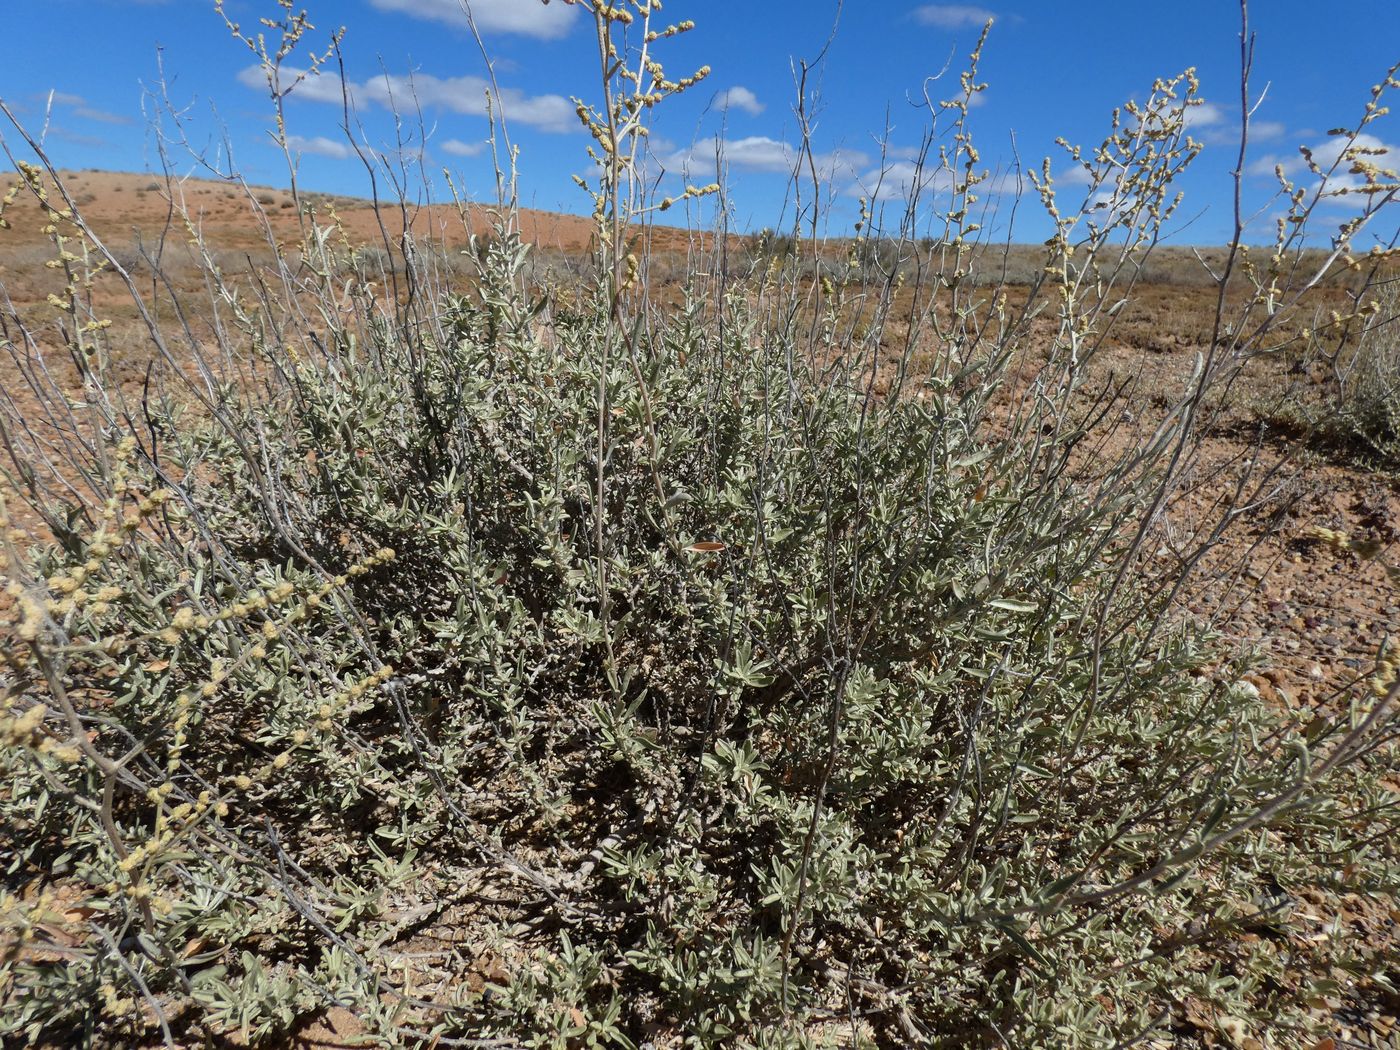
left=0, top=0, right=1400, bottom=244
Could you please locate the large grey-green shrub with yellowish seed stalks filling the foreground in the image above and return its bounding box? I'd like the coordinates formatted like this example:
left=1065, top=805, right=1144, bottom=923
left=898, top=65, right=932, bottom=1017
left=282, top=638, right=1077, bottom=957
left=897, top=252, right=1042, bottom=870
left=0, top=4, right=1397, bottom=1047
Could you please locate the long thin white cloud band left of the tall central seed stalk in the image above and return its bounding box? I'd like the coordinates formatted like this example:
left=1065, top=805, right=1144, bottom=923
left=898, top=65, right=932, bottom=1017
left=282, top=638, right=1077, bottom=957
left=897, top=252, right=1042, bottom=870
left=238, top=66, right=578, bottom=132
